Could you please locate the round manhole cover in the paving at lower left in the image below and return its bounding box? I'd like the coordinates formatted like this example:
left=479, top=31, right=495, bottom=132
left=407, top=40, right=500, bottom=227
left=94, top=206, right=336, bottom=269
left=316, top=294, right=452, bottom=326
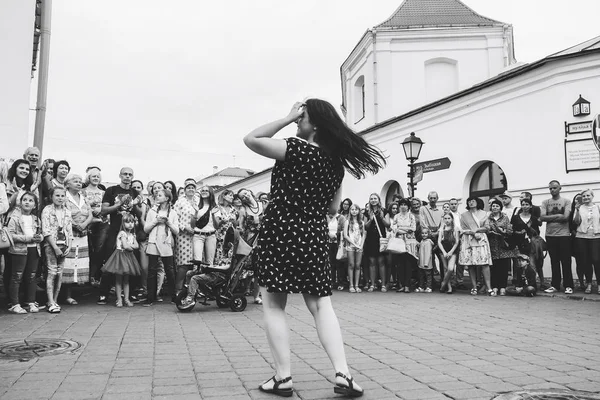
left=0, top=339, right=81, bottom=360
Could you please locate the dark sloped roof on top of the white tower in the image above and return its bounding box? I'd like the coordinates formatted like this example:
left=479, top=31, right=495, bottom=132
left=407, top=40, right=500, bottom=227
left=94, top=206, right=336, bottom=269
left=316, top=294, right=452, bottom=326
left=375, top=0, right=505, bottom=29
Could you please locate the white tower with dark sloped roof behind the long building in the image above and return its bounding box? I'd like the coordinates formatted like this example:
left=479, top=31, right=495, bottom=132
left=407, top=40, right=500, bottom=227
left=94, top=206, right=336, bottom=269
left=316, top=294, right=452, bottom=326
left=340, top=0, right=516, bottom=131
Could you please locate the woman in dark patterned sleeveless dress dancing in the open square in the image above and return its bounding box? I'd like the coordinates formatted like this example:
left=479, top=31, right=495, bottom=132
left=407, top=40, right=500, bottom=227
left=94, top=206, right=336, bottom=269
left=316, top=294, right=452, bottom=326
left=244, top=99, right=385, bottom=397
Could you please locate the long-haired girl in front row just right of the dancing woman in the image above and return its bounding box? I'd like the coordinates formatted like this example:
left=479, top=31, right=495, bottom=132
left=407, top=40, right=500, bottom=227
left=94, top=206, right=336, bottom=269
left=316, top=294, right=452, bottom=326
left=340, top=204, right=366, bottom=293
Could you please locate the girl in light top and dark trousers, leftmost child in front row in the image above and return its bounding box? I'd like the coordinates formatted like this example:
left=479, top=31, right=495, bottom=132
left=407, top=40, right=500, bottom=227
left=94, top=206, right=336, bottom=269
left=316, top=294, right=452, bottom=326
left=8, top=191, right=44, bottom=314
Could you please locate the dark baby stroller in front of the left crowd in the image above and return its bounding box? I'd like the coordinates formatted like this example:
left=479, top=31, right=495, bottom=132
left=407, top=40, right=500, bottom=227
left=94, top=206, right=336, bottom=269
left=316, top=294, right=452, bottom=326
left=175, top=228, right=256, bottom=312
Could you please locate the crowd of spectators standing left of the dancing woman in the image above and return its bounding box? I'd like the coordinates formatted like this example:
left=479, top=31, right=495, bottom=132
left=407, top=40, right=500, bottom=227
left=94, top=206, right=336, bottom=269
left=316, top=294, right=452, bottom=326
left=0, top=147, right=269, bottom=314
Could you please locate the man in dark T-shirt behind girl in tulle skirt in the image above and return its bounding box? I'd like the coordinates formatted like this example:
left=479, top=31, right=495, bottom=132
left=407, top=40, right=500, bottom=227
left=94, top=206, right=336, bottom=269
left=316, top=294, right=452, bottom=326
left=97, top=167, right=141, bottom=304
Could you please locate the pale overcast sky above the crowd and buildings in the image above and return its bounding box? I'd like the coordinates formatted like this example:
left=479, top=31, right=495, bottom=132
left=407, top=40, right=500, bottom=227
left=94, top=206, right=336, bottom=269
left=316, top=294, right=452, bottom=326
left=32, top=0, right=600, bottom=184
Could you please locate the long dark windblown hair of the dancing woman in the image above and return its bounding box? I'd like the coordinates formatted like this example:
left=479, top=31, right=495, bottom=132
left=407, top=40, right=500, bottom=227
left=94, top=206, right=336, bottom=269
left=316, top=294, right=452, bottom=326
left=305, top=99, right=386, bottom=179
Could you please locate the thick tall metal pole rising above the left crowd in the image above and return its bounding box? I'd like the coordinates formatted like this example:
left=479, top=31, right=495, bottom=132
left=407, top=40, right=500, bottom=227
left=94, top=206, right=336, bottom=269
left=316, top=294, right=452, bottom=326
left=33, top=0, right=52, bottom=158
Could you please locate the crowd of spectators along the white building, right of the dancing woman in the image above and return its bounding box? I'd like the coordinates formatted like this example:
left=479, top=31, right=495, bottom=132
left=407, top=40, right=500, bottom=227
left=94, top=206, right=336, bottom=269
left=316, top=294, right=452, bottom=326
left=328, top=184, right=600, bottom=296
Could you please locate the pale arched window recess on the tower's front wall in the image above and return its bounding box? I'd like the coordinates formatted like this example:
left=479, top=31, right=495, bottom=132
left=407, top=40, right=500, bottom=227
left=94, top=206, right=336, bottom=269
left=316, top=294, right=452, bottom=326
left=425, top=57, right=458, bottom=101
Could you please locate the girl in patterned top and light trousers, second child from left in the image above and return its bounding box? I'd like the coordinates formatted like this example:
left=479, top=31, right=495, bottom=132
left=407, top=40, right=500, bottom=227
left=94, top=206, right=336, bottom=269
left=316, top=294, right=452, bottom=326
left=42, top=186, right=73, bottom=314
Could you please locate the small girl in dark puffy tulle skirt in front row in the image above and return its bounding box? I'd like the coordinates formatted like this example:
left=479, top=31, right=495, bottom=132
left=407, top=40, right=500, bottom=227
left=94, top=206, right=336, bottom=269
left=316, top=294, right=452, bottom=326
left=102, top=213, right=142, bottom=307
